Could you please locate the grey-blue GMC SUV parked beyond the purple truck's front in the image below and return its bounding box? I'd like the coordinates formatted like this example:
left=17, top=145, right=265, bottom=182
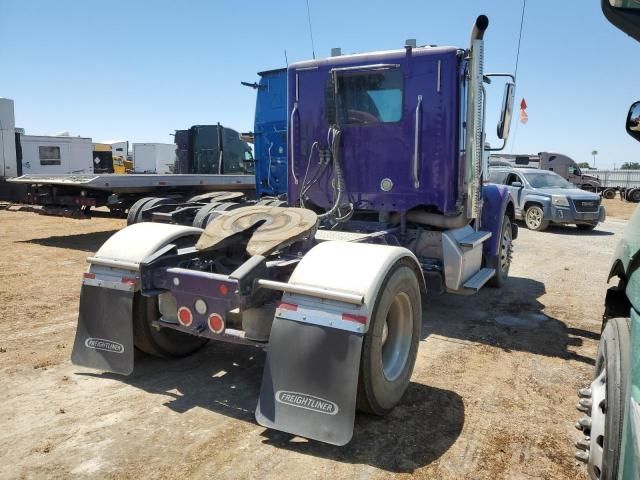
left=487, top=167, right=606, bottom=231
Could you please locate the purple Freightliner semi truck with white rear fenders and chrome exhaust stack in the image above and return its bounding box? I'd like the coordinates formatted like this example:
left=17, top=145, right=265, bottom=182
left=72, top=16, right=517, bottom=445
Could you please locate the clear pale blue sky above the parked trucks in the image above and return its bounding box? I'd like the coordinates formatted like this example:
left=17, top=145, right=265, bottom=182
left=0, top=0, right=640, bottom=168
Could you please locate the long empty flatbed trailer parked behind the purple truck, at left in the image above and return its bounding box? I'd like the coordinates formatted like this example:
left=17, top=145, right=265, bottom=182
left=8, top=174, right=255, bottom=216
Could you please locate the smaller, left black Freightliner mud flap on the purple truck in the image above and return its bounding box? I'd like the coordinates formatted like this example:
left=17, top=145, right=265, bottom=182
left=71, top=285, right=134, bottom=375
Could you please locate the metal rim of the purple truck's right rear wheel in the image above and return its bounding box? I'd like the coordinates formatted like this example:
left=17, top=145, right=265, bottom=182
left=380, top=292, right=413, bottom=381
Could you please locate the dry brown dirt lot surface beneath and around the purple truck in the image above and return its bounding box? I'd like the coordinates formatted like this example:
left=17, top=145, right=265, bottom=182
left=0, top=207, right=625, bottom=479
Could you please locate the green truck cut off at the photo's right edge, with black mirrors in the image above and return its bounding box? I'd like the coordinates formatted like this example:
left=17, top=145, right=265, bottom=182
left=575, top=0, right=640, bottom=480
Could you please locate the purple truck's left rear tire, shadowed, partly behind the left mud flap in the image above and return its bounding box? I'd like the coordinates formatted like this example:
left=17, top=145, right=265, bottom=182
left=133, top=293, right=208, bottom=358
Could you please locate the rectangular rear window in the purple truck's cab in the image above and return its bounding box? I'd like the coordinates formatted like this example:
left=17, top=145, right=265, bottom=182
left=337, top=69, right=402, bottom=125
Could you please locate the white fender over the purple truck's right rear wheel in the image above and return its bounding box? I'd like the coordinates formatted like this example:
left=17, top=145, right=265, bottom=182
left=276, top=241, right=424, bottom=333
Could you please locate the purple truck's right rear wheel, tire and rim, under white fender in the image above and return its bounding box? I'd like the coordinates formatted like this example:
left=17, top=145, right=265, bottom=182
left=357, top=260, right=422, bottom=415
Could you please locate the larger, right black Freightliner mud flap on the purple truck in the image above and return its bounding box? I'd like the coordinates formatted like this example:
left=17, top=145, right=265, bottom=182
left=256, top=317, right=362, bottom=445
